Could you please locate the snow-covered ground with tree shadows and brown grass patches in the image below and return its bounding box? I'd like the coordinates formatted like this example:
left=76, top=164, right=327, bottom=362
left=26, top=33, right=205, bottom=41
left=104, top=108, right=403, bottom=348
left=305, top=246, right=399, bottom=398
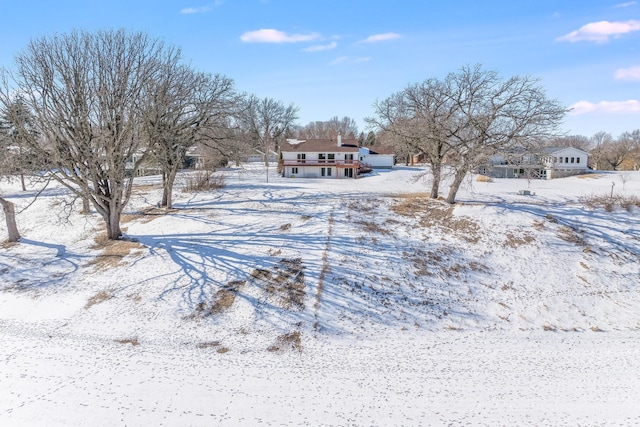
left=0, top=167, right=640, bottom=426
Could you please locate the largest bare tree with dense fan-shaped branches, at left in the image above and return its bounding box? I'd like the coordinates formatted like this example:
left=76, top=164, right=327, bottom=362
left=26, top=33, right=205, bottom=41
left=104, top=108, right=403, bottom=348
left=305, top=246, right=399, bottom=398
left=0, top=30, right=179, bottom=239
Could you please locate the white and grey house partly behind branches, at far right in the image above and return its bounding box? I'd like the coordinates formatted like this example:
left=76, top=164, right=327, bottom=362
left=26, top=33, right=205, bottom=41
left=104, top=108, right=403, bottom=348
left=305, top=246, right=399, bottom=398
left=478, top=147, right=589, bottom=179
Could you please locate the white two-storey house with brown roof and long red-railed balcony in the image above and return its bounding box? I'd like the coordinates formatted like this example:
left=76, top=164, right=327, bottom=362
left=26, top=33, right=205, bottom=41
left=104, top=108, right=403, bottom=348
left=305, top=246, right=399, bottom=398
left=280, top=135, right=393, bottom=178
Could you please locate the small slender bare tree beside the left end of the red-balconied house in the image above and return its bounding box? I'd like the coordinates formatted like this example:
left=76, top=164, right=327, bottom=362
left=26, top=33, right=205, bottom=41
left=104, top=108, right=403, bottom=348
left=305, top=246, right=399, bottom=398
left=241, top=95, right=298, bottom=182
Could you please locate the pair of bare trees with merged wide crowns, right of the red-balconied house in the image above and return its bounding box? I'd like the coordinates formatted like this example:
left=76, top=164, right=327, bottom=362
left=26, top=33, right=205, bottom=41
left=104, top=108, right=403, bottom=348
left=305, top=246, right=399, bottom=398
left=368, top=65, right=567, bottom=203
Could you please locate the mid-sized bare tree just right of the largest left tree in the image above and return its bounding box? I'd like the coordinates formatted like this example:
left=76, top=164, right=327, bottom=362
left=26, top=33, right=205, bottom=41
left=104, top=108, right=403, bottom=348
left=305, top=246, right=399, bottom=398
left=144, top=65, right=239, bottom=208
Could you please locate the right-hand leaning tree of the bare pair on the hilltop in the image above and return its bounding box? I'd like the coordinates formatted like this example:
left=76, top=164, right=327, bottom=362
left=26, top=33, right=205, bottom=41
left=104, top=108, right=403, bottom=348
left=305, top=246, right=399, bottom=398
left=445, top=65, right=568, bottom=203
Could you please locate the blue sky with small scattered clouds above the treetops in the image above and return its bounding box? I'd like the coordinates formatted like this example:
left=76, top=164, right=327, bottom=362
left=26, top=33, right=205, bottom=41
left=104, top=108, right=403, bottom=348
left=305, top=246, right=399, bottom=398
left=0, top=0, right=640, bottom=136
